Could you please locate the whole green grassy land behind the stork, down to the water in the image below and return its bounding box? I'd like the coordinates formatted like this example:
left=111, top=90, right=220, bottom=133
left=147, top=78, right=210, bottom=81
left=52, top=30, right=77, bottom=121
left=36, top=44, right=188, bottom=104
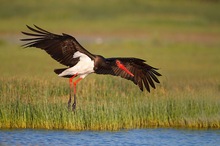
left=0, top=0, right=220, bottom=130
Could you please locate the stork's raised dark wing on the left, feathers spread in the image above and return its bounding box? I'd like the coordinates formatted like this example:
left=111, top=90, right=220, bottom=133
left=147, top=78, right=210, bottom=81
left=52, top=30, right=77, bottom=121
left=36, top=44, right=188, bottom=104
left=21, top=25, right=94, bottom=66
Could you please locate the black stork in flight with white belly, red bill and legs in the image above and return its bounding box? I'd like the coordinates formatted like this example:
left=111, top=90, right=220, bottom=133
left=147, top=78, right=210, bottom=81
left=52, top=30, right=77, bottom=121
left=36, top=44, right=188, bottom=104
left=21, top=25, right=161, bottom=110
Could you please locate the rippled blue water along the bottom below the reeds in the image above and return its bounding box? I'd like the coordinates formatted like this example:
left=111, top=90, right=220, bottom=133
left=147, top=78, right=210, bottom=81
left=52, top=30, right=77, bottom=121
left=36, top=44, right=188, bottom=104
left=0, top=128, right=220, bottom=146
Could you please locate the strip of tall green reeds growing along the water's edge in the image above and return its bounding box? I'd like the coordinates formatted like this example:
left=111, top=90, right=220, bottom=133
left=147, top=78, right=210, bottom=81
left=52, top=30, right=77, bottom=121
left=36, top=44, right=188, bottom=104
left=0, top=77, right=220, bottom=130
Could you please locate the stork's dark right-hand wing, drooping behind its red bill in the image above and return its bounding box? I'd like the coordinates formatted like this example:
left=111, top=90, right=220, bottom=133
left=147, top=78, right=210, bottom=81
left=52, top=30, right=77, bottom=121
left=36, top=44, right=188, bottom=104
left=95, top=58, right=161, bottom=92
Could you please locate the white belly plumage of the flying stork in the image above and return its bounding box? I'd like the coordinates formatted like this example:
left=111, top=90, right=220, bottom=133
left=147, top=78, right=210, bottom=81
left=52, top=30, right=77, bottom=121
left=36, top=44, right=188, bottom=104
left=59, top=51, right=94, bottom=78
